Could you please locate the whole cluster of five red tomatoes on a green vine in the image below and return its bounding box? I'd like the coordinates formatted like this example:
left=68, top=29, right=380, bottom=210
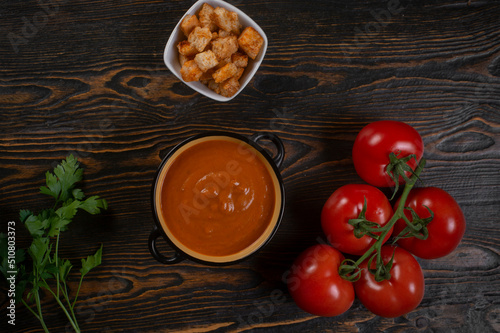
left=287, top=121, right=465, bottom=318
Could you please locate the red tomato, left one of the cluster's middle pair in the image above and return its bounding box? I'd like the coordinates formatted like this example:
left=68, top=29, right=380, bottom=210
left=321, top=184, right=392, bottom=255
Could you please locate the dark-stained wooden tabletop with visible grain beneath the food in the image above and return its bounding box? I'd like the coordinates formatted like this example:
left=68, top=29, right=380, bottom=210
left=0, top=0, right=500, bottom=332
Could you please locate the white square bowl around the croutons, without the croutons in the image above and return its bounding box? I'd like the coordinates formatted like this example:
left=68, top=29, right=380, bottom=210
left=163, top=0, right=267, bottom=102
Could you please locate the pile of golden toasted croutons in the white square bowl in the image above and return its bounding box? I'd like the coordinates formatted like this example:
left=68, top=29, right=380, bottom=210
left=177, top=3, right=264, bottom=97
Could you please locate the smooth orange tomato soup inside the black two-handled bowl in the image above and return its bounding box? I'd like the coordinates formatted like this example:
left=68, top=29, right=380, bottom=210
left=158, top=138, right=278, bottom=257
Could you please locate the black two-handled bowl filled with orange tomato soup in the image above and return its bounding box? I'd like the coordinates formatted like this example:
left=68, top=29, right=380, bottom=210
left=149, top=132, right=285, bottom=265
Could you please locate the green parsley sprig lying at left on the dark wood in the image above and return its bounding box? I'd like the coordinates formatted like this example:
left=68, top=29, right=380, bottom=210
left=0, top=155, right=107, bottom=332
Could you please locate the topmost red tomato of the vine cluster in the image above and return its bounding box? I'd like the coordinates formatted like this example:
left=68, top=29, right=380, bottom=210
left=352, top=120, right=424, bottom=187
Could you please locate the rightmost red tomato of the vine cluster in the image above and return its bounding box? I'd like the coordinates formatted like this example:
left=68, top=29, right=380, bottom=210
left=394, top=187, right=465, bottom=259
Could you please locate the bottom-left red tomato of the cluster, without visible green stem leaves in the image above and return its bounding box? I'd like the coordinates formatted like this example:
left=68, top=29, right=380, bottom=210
left=286, top=244, right=354, bottom=317
